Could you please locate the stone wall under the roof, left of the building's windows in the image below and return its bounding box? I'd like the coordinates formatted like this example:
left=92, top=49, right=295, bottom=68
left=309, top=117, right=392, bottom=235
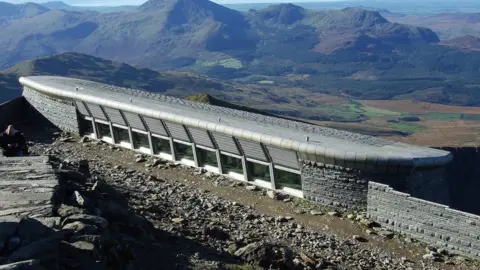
left=23, top=87, right=79, bottom=133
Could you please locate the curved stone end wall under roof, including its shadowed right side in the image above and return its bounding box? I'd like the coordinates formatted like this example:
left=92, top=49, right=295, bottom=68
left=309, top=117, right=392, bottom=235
left=301, top=160, right=450, bottom=209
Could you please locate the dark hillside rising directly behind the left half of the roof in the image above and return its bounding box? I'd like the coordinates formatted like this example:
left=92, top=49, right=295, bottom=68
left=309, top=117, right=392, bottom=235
left=0, top=53, right=249, bottom=97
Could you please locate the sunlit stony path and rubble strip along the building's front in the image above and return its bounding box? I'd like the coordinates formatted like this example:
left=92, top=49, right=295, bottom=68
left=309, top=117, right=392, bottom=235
left=23, top=125, right=479, bottom=269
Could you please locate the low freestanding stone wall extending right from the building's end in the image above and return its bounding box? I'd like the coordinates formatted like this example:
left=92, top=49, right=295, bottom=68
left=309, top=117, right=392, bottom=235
left=367, top=182, right=480, bottom=259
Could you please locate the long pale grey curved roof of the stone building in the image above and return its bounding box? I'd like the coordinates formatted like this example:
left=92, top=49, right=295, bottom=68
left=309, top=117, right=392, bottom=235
left=20, top=76, right=452, bottom=167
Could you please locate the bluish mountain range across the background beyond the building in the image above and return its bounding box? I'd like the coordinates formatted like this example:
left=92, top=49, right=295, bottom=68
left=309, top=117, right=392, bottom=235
left=0, top=0, right=480, bottom=105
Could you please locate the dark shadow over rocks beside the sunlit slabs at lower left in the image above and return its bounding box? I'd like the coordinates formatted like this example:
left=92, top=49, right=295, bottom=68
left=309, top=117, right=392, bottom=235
left=44, top=155, right=242, bottom=270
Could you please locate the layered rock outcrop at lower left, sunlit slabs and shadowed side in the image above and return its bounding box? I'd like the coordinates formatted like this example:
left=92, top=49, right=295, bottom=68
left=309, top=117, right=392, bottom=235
left=0, top=157, right=155, bottom=269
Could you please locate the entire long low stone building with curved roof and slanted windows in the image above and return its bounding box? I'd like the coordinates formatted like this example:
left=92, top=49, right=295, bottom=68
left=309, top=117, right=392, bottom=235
left=20, top=76, right=452, bottom=209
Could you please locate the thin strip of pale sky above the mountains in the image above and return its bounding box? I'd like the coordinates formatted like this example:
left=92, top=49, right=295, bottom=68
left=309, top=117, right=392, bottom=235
left=0, top=0, right=348, bottom=6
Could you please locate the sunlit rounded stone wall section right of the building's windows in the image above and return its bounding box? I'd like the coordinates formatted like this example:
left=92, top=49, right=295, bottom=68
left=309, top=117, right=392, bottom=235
left=301, top=162, right=368, bottom=208
